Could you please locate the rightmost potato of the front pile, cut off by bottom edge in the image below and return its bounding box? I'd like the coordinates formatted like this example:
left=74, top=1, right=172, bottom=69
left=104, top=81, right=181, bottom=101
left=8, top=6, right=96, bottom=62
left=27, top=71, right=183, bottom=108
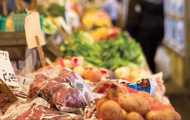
left=146, top=109, right=181, bottom=120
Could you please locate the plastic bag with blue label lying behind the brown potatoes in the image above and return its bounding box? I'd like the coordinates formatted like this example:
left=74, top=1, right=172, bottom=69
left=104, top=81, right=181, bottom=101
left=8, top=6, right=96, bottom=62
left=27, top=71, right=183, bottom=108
left=95, top=73, right=170, bottom=104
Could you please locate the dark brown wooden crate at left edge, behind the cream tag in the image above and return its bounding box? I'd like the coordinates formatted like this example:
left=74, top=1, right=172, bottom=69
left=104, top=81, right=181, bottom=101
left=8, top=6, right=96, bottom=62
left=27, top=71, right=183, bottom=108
left=0, top=32, right=27, bottom=61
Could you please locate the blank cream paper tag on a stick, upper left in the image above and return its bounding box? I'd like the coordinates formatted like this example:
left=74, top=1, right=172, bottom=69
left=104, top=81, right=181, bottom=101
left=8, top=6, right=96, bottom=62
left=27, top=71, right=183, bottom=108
left=24, top=12, right=46, bottom=49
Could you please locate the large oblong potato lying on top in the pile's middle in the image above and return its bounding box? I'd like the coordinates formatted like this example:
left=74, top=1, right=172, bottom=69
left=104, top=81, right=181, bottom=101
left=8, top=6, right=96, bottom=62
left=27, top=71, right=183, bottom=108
left=118, top=94, right=151, bottom=115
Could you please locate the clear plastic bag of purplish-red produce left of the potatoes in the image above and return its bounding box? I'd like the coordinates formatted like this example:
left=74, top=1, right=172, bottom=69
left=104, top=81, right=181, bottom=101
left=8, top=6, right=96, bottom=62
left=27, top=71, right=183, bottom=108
left=29, top=69, right=93, bottom=112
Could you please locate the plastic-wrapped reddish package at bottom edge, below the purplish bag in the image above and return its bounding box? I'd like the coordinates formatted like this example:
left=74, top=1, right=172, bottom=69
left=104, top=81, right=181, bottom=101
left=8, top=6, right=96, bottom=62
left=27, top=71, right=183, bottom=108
left=16, top=106, right=82, bottom=120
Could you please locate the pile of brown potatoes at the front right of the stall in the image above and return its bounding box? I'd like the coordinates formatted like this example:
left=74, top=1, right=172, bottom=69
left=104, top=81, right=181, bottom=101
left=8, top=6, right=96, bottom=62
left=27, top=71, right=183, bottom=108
left=96, top=89, right=181, bottom=120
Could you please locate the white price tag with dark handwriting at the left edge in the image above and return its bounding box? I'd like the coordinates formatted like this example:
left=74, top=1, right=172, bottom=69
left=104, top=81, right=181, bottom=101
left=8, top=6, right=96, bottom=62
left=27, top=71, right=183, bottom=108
left=0, top=50, right=19, bottom=87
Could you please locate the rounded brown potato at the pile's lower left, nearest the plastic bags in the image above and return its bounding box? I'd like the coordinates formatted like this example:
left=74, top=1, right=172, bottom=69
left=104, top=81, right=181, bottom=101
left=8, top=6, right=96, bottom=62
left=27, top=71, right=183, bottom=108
left=98, top=100, right=124, bottom=120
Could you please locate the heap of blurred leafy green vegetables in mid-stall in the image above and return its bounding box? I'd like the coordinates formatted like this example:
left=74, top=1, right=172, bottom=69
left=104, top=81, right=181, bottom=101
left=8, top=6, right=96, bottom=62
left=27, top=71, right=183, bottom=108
left=61, top=31, right=145, bottom=70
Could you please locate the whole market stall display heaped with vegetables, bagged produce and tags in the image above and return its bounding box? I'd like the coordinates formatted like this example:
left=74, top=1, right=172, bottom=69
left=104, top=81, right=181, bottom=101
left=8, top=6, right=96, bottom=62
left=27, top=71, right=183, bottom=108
left=0, top=0, right=181, bottom=120
